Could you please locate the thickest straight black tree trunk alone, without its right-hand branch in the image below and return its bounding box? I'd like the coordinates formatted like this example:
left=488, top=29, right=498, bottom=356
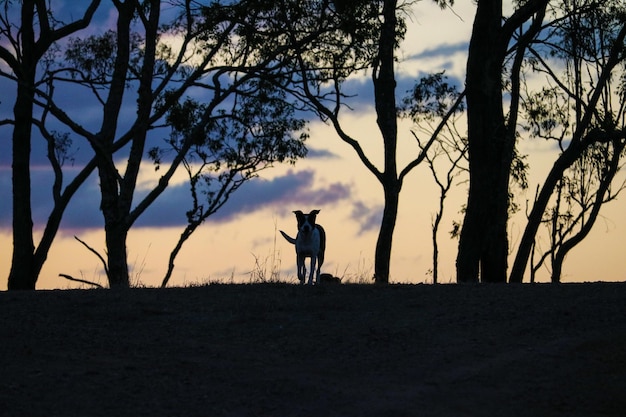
left=457, top=0, right=514, bottom=282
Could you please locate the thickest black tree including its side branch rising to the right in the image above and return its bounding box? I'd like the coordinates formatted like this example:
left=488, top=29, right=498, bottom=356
left=456, top=0, right=548, bottom=282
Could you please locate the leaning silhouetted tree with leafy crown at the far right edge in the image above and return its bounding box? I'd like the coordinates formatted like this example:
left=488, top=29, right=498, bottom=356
left=510, top=0, right=626, bottom=282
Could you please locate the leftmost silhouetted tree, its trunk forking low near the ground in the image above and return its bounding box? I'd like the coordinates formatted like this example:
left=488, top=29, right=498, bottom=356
left=0, top=0, right=100, bottom=290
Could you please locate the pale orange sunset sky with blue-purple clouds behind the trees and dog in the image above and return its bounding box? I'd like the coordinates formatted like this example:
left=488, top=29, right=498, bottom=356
left=0, top=0, right=626, bottom=289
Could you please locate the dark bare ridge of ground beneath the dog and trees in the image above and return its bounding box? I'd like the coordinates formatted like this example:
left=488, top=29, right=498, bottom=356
left=0, top=283, right=626, bottom=417
